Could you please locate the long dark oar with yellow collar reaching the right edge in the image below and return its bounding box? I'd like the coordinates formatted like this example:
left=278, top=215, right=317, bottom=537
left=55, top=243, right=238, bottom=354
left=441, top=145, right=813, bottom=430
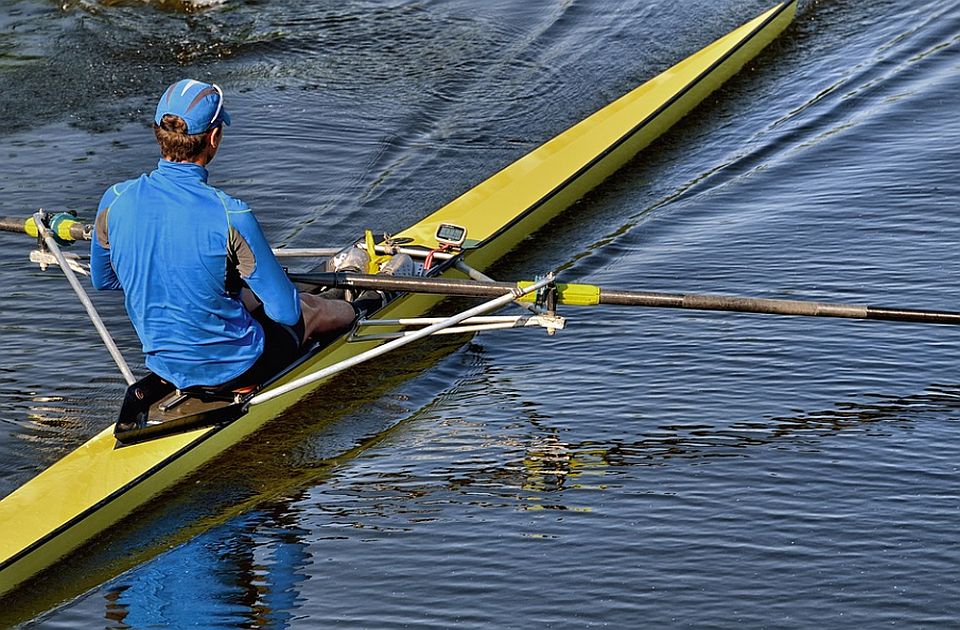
left=290, top=272, right=960, bottom=325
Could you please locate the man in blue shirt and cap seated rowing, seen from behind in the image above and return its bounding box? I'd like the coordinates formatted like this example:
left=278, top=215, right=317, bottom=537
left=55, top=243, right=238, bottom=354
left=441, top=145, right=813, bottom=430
left=90, top=79, right=356, bottom=389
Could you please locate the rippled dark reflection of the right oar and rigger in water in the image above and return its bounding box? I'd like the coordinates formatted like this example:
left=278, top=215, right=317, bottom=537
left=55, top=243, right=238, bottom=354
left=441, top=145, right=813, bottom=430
left=329, top=375, right=960, bottom=528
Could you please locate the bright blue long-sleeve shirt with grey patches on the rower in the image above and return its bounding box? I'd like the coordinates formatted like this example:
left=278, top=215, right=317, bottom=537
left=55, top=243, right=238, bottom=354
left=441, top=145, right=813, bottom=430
left=90, top=160, right=301, bottom=387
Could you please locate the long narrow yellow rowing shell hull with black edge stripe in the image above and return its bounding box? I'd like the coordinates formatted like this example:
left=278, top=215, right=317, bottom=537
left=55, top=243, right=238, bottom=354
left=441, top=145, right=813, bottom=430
left=0, top=0, right=796, bottom=594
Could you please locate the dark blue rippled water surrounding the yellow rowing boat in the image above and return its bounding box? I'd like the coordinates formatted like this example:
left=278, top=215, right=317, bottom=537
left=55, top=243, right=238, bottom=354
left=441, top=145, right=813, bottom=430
left=0, top=0, right=960, bottom=628
